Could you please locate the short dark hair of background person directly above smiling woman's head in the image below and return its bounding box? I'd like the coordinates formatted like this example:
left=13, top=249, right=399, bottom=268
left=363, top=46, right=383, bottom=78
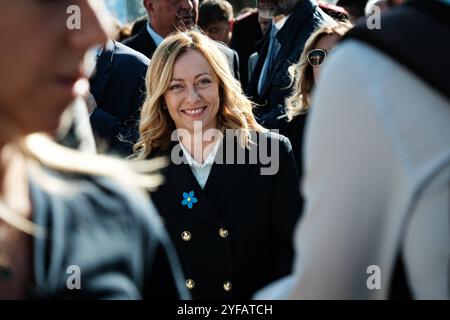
left=198, top=0, right=233, bottom=29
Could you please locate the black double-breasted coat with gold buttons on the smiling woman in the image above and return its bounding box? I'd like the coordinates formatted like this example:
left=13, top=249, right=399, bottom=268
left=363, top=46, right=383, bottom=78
left=151, top=133, right=300, bottom=299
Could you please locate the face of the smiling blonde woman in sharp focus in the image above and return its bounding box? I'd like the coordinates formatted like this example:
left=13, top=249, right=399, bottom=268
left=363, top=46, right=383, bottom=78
left=164, top=50, right=220, bottom=133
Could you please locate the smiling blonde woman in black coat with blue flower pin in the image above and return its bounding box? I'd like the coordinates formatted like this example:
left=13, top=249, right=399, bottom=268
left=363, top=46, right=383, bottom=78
left=135, top=31, right=300, bottom=299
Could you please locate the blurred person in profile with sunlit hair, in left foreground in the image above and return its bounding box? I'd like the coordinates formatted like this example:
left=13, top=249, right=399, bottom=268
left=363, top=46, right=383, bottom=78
left=0, top=0, right=189, bottom=299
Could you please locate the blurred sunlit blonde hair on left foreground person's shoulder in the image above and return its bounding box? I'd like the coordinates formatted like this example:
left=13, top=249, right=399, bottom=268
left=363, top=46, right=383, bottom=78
left=0, top=113, right=166, bottom=237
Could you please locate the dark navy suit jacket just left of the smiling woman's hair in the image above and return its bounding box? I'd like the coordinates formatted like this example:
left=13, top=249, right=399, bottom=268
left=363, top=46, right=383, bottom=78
left=90, top=41, right=150, bottom=156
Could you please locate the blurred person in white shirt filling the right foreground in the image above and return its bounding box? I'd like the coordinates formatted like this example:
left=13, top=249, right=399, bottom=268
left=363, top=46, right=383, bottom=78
left=256, top=0, right=450, bottom=300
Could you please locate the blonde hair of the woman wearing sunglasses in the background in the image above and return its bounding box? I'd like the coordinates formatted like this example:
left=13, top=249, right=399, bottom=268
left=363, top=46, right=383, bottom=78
left=286, top=22, right=353, bottom=120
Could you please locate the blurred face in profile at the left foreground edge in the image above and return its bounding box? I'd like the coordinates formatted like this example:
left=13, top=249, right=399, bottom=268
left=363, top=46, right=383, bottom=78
left=0, top=0, right=106, bottom=134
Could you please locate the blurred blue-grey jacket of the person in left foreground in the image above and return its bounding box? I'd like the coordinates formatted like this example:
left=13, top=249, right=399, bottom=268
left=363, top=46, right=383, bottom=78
left=30, top=173, right=189, bottom=299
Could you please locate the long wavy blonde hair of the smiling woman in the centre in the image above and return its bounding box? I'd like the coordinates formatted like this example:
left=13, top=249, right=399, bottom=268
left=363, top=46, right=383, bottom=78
left=134, top=31, right=265, bottom=160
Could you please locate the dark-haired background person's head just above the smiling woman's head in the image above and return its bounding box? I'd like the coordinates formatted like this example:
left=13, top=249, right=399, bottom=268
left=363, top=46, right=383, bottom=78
left=198, top=0, right=234, bottom=46
